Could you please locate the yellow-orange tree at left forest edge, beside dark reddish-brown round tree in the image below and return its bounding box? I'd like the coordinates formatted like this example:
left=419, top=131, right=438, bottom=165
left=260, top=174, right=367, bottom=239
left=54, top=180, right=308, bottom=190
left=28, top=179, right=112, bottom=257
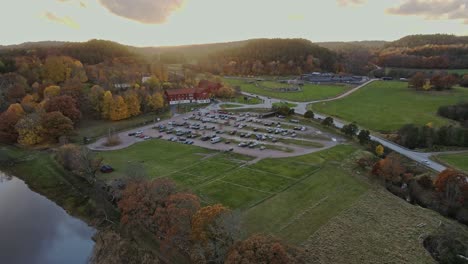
left=15, top=113, right=44, bottom=146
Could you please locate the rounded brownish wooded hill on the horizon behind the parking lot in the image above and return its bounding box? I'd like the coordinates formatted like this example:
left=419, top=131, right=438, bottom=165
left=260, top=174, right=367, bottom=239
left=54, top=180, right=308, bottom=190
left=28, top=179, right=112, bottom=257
left=198, top=39, right=336, bottom=75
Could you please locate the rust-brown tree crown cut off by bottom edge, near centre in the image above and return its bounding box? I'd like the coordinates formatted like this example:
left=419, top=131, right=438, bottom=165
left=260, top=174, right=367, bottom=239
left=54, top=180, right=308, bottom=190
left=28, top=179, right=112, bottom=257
left=224, top=234, right=307, bottom=264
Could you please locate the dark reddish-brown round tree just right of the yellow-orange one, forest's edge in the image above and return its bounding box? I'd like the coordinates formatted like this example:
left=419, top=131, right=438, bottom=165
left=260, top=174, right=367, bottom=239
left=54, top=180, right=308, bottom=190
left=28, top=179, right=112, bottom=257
left=41, top=111, right=73, bottom=141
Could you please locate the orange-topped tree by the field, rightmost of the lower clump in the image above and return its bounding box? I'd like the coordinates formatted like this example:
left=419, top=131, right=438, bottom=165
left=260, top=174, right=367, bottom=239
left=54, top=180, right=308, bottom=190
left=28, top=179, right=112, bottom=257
left=191, top=204, right=239, bottom=263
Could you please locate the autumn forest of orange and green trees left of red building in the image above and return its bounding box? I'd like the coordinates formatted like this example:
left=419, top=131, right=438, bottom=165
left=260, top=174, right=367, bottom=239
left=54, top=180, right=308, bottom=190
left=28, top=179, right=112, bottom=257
left=0, top=40, right=171, bottom=146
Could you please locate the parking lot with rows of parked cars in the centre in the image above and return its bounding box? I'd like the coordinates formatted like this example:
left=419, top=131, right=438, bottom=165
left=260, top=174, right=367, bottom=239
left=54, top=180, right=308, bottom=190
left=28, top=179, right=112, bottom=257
left=89, top=109, right=344, bottom=158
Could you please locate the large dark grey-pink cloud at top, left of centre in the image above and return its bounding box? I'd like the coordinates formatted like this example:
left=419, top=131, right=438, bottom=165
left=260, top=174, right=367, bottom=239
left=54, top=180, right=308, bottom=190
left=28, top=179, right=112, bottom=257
left=98, top=0, right=186, bottom=24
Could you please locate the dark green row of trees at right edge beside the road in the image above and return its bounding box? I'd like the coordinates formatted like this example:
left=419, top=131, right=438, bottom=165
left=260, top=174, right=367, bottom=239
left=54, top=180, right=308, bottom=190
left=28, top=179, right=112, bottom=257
left=397, top=124, right=468, bottom=149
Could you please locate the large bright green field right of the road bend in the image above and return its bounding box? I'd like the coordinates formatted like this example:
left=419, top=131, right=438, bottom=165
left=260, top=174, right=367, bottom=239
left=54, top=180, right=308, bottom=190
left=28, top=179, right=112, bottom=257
left=312, top=81, right=468, bottom=132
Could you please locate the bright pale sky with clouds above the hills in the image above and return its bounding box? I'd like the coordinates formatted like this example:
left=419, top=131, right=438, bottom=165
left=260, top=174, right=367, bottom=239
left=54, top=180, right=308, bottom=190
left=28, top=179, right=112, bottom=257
left=0, top=0, right=468, bottom=47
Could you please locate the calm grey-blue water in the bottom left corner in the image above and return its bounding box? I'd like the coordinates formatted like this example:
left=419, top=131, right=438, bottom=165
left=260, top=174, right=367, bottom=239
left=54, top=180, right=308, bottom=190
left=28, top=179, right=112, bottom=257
left=0, top=172, right=94, bottom=264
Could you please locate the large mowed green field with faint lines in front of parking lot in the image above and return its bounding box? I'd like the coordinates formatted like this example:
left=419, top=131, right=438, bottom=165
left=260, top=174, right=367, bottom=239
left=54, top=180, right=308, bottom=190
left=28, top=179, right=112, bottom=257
left=100, top=140, right=368, bottom=243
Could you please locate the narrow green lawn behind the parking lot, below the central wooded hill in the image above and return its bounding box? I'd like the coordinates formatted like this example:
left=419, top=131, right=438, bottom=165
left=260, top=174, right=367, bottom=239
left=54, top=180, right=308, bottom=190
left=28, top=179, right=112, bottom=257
left=224, top=79, right=351, bottom=102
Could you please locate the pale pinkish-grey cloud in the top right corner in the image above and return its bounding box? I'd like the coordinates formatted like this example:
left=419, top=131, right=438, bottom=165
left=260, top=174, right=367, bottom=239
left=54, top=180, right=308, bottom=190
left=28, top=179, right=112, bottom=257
left=387, top=0, right=468, bottom=24
